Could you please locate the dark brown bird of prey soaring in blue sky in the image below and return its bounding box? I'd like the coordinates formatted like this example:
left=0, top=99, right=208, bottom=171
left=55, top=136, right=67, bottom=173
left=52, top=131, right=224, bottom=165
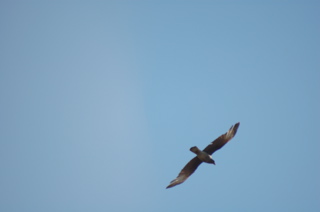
left=167, top=122, right=240, bottom=188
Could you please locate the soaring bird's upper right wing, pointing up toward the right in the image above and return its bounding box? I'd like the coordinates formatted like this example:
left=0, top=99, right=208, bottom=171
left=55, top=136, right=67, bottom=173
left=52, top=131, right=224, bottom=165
left=203, top=122, right=240, bottom=155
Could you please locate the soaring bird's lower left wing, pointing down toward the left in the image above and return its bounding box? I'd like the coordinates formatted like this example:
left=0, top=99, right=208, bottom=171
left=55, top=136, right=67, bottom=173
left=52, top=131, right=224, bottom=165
left=167, top=156, right=202, bottom=188
